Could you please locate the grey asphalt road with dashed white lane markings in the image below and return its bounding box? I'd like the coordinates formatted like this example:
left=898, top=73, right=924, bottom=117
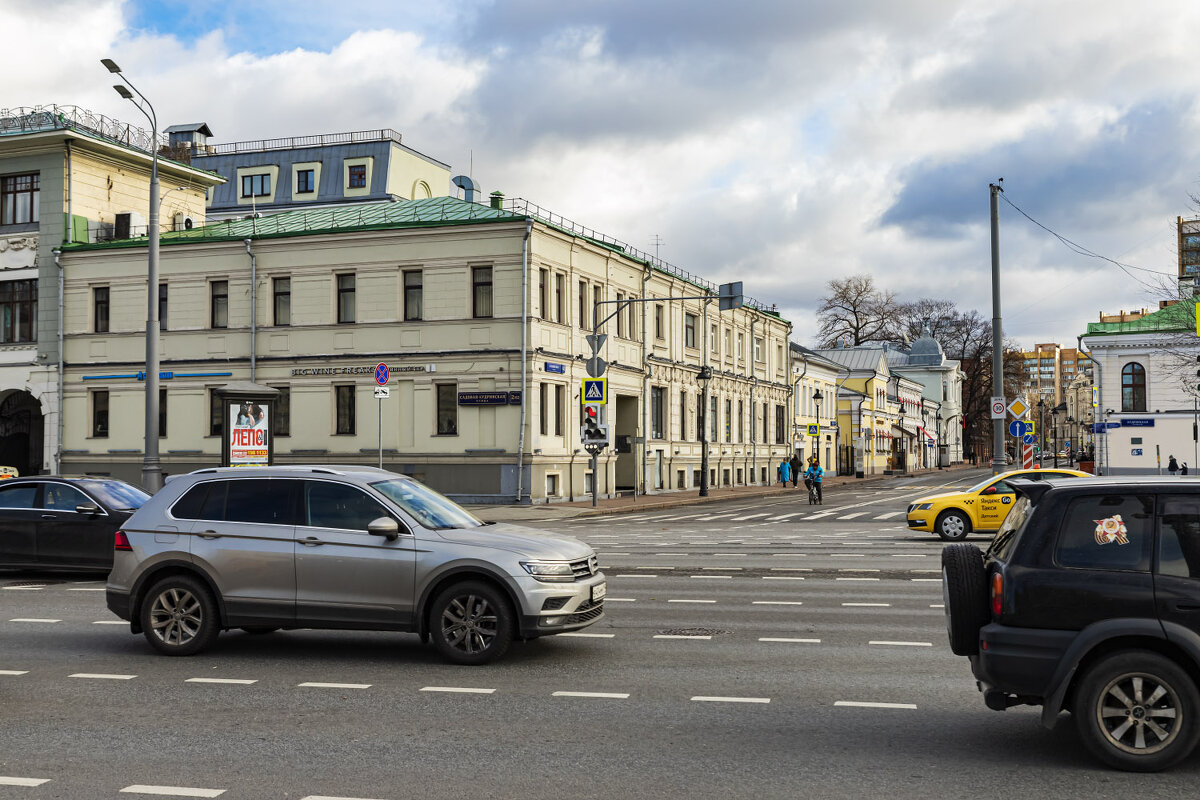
left=0, top=473, right=1200, bottom=800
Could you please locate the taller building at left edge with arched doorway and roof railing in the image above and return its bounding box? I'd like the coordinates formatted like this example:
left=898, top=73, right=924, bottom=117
left=0, top=106, right=222, bottom=474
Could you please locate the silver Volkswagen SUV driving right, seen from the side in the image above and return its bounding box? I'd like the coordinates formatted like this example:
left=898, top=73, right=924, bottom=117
left=106, top=467, right=606, bottom=664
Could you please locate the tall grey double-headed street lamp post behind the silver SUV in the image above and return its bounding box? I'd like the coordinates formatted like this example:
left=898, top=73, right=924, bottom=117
left=100, top=59, right=162, bottom=494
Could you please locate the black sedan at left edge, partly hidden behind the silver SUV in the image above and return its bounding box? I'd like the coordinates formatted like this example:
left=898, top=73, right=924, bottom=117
left=0, top=476, right=150, bottom=572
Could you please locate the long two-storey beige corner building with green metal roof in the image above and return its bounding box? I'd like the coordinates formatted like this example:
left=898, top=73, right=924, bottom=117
left=62, top=198, right=791, bottom=501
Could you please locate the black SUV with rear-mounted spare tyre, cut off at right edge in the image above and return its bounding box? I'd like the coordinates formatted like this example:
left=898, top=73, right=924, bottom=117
left=942, top=477, right=1200, bottom=771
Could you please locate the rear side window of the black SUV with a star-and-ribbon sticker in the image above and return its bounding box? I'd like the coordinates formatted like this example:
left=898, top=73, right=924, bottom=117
left=1057, top=494, right=1154, bottom=572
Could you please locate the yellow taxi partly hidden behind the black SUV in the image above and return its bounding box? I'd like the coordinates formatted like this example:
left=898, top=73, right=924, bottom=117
left=908, top=469, right=1091, bottom=542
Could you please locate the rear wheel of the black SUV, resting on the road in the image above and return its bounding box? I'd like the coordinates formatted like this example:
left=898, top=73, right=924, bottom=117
left=1074, top=650, right=1200, bottom=772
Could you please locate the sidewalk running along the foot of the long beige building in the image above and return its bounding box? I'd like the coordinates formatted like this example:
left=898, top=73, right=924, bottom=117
left=466, top=464, right=978, bottom=522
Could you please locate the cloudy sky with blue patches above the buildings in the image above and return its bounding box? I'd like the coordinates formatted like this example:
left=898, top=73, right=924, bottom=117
left=0, top=0, right=1200, bottom=345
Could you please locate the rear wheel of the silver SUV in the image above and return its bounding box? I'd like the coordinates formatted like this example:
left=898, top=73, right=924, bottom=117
left=140, top=575, right=220, bottom=656
